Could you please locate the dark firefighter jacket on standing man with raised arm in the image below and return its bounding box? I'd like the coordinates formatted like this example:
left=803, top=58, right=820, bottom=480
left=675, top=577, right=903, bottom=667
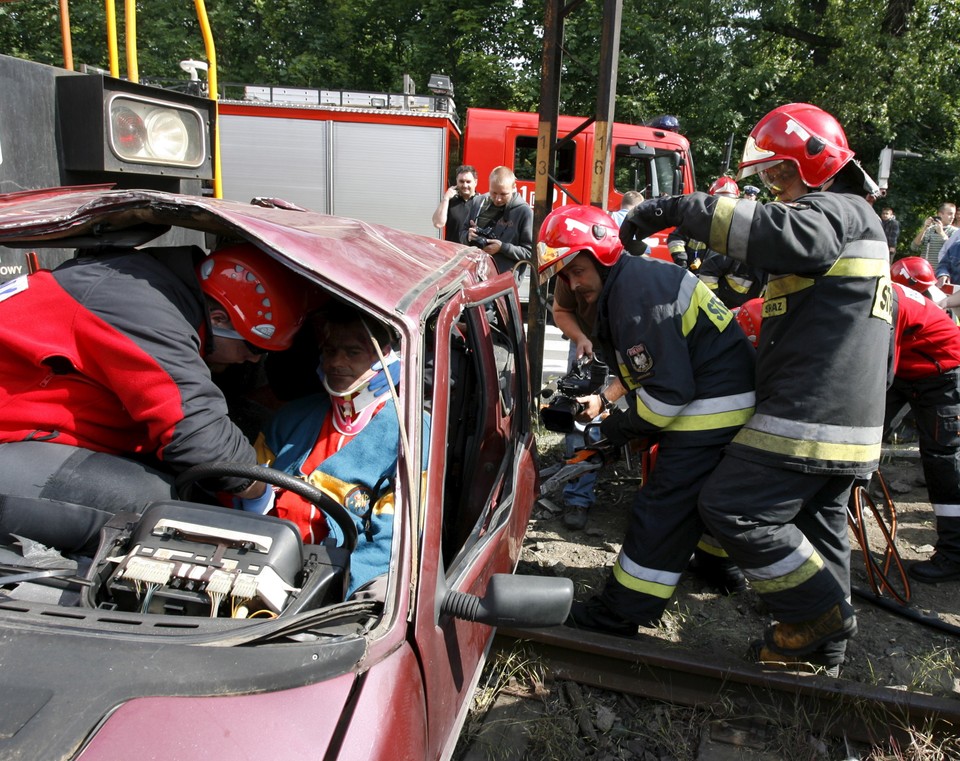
left=621, top=189, right=892, bottom=474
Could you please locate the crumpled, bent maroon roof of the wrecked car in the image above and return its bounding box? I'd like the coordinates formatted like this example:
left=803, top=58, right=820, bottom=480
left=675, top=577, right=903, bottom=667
left=0, top=186, right=484, bottom=317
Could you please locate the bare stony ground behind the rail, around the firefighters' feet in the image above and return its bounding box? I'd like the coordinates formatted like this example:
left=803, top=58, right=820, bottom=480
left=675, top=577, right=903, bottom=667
left=521, top=434, right=960, bottom=697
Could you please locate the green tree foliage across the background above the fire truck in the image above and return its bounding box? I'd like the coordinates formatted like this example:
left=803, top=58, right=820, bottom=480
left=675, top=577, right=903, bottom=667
left=7, top=0, right=960, bottom=223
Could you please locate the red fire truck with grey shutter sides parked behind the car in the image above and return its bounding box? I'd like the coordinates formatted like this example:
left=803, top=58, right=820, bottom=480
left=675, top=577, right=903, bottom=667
left=219, top=86, right=695, bottom=258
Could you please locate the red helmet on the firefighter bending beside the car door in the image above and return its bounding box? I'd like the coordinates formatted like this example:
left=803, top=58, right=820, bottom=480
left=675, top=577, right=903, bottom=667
left=537, top=205, right=623, bottom=283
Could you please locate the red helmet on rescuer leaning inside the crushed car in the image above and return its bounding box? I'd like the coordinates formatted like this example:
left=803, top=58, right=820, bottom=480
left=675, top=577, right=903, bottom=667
left=197, top=243, right=310, bottom=351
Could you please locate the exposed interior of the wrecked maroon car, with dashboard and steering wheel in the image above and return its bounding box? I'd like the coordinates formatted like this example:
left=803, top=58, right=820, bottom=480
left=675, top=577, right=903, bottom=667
left=0, top=235, right=529, bottom=630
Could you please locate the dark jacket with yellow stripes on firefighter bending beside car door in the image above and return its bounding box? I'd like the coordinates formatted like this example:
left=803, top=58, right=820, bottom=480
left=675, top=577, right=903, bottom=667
left=596, top=256, right=755, bottom=446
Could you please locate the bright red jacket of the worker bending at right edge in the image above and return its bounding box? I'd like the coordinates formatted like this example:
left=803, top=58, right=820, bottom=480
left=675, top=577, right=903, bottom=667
left=893, top=283, right=960, bottom=380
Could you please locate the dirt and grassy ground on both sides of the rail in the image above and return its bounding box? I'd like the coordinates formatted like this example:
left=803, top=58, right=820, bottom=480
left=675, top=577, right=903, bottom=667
left=454, top=433, right=960, bottom=761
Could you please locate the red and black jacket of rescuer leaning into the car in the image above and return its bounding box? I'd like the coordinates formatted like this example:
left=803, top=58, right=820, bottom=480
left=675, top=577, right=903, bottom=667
left=0, top=247, right=256, bottom=490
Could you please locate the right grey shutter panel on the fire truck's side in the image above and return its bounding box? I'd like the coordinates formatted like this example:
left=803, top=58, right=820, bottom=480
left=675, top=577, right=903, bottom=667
left=332, top=122, right=446, bottom=238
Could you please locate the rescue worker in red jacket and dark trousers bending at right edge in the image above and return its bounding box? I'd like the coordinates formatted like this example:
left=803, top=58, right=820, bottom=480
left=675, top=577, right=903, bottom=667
left=885, top=280, right=960, bottom=583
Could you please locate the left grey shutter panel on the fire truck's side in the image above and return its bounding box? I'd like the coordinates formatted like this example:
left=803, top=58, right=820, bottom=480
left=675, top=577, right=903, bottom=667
left=220, top=115, right=330, bottom=213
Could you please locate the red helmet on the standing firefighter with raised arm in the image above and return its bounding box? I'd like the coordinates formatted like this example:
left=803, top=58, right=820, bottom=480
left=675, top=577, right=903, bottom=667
left=737, top=103, right=853, bottom=188
